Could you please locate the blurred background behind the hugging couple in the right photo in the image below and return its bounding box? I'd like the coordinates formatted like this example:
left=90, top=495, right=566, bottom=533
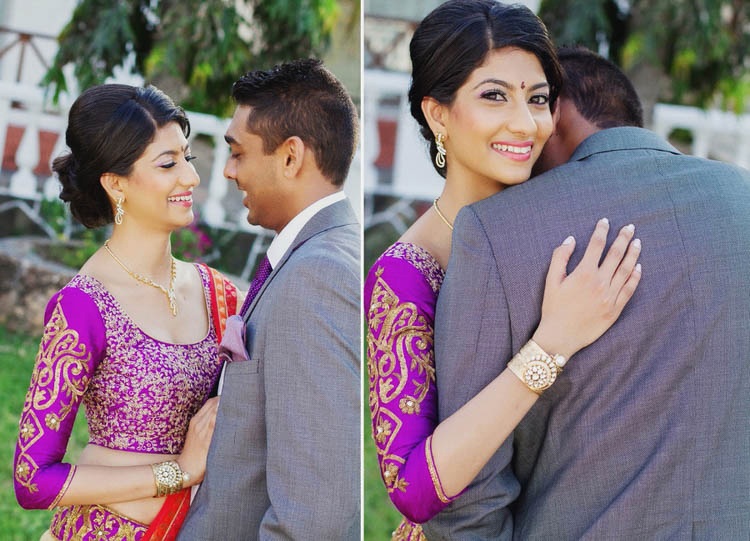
left=362, top=0, right=750, bottom=541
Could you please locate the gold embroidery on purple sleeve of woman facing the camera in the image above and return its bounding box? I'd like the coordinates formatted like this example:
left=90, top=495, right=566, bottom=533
left=367, top=267, right=435, bottom=492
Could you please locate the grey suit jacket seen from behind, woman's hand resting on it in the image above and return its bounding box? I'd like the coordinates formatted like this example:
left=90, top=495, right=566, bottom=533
left=425, top=128, right=750, bottom=541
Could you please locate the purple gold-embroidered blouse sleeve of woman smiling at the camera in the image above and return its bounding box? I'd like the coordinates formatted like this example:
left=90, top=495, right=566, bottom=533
left=364, top=242, right=452, bottom=523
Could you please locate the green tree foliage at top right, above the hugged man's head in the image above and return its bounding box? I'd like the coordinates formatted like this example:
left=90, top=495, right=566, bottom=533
left=539, top=0, right=750, bottom=112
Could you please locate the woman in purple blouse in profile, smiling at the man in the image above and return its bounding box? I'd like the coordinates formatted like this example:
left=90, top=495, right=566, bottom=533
left=14, top=85, right=236, bottom=541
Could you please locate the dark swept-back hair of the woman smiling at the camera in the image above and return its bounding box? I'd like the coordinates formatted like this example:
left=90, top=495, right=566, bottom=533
left=409, top=0, right=563, bottom=177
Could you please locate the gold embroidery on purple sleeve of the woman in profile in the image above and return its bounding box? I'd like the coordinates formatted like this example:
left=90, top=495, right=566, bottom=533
left=15, top=295, right=91, bottom=497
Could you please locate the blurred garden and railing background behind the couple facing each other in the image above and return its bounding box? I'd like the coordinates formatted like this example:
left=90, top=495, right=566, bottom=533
left=0, top=0, right=362, bottom=541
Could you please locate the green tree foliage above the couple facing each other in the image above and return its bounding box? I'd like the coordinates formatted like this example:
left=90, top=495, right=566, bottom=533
left=44, top=0, right=350, bottom=115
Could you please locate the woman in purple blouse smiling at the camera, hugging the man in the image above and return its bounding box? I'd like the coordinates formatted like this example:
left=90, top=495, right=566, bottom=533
left=364, top=0, right=641, bottom=540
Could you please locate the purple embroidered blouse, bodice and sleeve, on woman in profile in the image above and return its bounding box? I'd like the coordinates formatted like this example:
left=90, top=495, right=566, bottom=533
left=14, top=266, right=221, bottom=509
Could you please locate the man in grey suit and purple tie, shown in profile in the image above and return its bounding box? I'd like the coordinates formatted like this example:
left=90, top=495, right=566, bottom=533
left=179, top=60, right=361, bottom=541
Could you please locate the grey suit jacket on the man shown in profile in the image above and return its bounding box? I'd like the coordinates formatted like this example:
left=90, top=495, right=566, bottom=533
left=179, top=201, right=362, bottom=541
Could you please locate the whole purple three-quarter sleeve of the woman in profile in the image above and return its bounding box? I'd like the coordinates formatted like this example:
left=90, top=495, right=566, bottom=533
left=13, top=287, right=106, bottom=509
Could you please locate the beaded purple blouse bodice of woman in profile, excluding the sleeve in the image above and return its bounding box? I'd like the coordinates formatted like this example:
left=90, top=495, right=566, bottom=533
left=71, top=268, right=221, bottom=454
